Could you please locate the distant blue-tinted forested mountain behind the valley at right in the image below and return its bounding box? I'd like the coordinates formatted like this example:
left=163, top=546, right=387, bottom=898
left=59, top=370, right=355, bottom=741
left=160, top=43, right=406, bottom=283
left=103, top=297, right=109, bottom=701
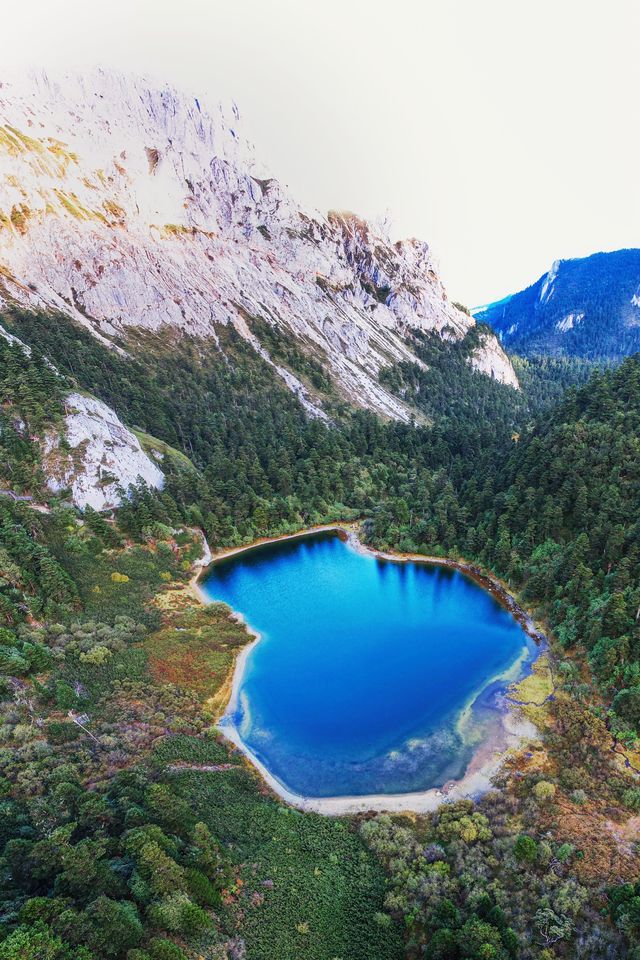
left=473, top=249, right=640, bottom=360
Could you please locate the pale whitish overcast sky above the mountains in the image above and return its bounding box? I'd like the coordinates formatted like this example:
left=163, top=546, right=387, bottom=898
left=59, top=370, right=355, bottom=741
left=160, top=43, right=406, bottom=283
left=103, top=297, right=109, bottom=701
left=5, top=0, right=640, bottom=306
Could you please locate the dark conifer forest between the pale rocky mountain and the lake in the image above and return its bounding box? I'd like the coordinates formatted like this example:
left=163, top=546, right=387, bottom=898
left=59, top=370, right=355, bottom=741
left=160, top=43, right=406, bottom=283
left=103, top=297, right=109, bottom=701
left=2, top=309, right=528, bottom=547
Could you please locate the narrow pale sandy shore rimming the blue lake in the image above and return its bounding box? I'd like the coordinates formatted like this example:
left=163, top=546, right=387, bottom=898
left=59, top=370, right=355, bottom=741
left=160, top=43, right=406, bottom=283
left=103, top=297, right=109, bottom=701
left=198, top=523, right=545, bottom=816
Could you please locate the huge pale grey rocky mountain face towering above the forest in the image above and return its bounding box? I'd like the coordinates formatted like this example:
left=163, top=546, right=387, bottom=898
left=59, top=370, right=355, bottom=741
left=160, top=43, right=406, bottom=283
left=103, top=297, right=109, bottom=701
left=0, top=72, right=518, bottom=420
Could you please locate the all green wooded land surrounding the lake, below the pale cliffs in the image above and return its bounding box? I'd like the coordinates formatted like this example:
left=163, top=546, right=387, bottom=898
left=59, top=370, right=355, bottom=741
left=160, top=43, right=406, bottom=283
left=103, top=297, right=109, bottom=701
left=0, top=310, right=640, bottom=960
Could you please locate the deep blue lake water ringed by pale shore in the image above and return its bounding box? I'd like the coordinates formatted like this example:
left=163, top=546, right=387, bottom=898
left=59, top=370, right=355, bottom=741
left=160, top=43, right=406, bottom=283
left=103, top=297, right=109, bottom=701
left=203, top=532, right=532, bottom=797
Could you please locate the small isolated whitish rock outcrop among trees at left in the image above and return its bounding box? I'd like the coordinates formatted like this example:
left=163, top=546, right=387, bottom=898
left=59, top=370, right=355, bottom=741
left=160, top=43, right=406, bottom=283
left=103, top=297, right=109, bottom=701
left=43, top=393, right=164, bottom=510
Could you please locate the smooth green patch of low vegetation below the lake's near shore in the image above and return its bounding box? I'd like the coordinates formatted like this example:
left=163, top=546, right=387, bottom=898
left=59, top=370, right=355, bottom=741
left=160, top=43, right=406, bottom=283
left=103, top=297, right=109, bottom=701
left=156, top=737, right=403, bottom=960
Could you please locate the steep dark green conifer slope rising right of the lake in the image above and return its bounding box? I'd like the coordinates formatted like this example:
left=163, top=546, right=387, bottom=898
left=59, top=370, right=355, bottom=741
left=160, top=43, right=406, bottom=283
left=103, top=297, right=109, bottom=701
left=371, top=356, right=640, bottom=732
